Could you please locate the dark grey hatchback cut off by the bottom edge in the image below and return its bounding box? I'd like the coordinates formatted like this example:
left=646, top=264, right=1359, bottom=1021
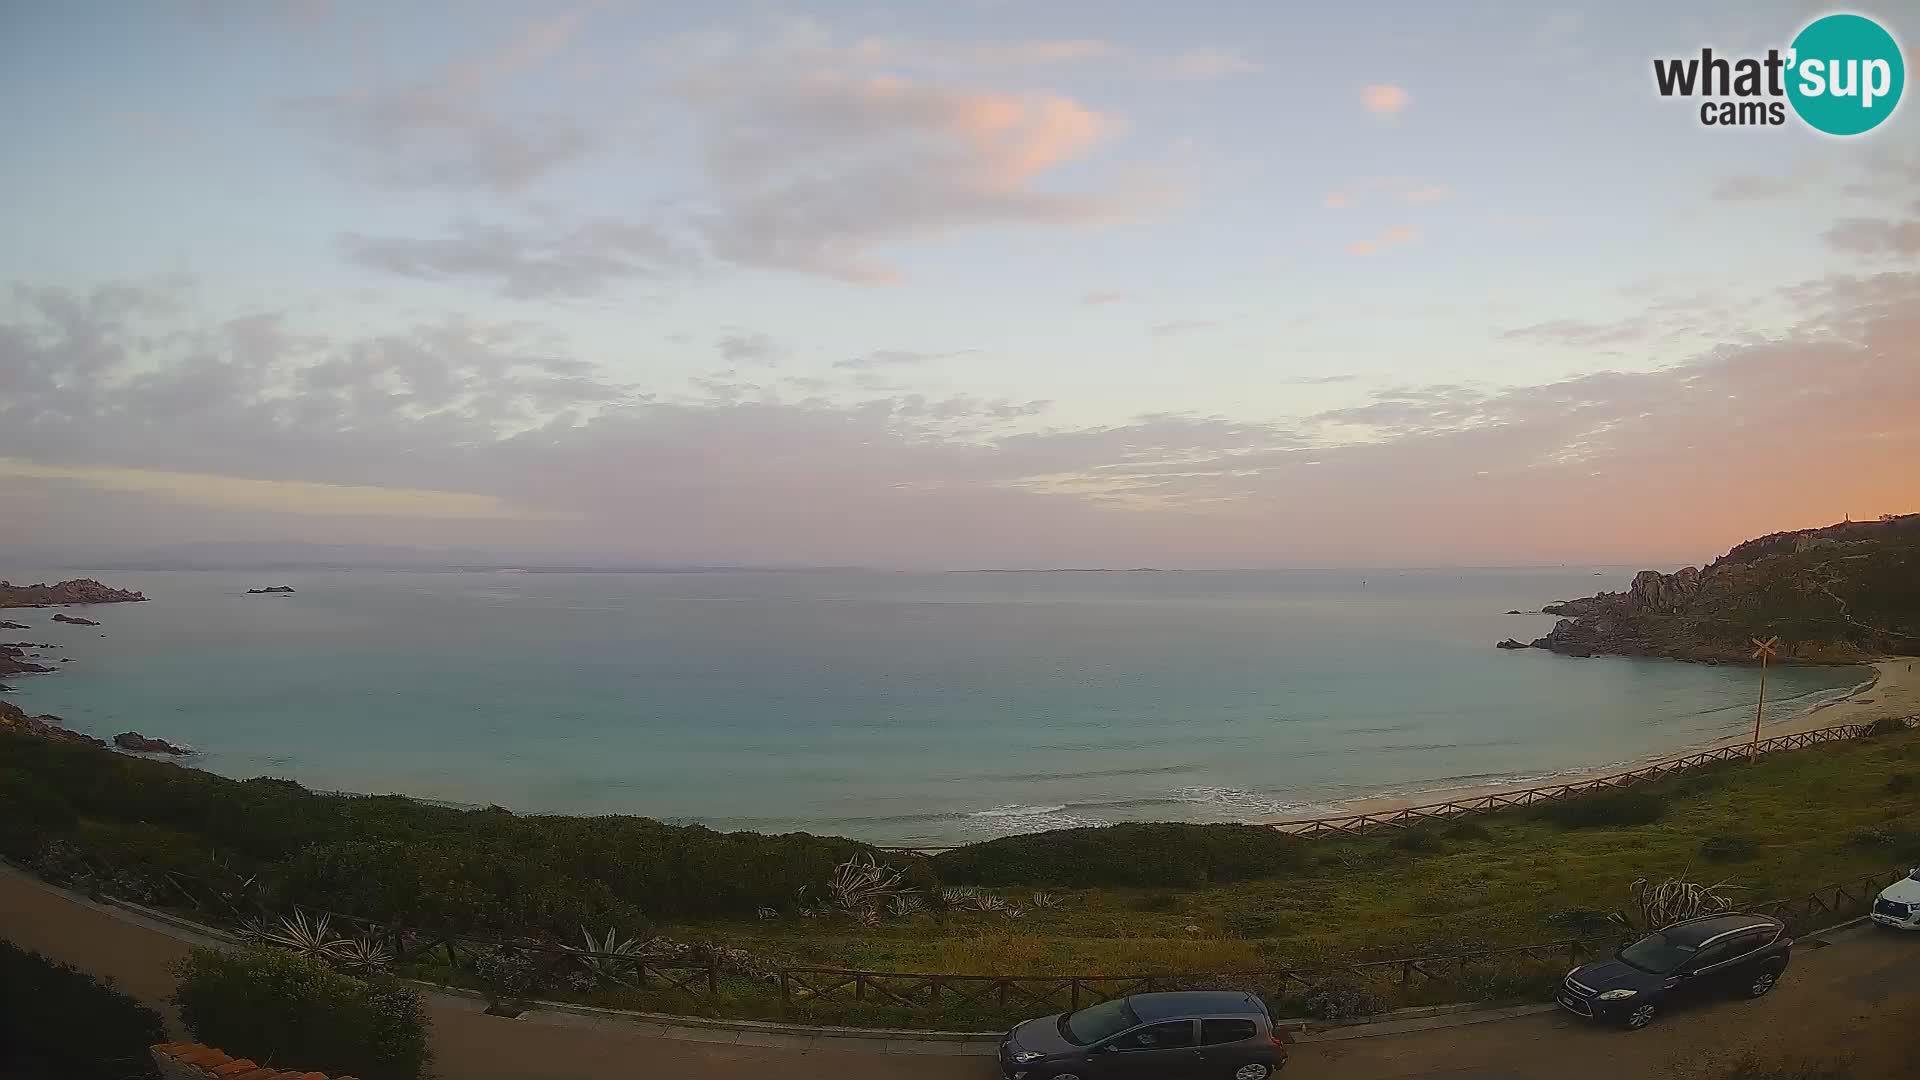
left=1000, top=990, right=1286, bottom=1080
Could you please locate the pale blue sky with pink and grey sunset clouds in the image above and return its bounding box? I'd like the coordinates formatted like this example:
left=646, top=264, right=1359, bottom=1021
left=0, top=0, right=1920, bottom=567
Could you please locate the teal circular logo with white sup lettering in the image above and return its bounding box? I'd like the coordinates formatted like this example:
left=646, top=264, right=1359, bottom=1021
left=1788, top=15, right=1907, bottom=135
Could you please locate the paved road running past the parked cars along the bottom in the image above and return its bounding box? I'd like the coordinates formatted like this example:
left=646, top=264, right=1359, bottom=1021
left=0, top=871, right=1920, bottom=1080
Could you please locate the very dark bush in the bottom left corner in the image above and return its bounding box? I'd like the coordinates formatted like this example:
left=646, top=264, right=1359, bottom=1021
left=0, top=940, right=167, bottom=1080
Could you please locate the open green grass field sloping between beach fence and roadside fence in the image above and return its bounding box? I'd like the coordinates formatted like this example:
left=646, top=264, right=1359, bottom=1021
left=666, top=732, right=1920, bottom=974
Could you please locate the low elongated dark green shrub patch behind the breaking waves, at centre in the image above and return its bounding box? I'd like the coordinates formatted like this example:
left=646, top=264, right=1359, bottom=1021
left=931, top=822, right=1306, bottom=888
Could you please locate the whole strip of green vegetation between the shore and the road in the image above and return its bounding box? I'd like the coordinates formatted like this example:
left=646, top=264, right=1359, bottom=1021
left=0, top=718, right=1920, bottom=1028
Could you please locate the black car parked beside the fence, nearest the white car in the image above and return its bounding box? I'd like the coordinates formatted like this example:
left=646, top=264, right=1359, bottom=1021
left=1553, top=915, right=1793, bottom=1030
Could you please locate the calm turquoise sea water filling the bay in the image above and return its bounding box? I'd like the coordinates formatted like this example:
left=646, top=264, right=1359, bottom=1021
left=0, top=567, right=1864, bottom=844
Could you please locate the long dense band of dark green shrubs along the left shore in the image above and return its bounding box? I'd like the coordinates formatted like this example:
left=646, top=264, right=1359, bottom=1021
left=0, top=732, right=894, bottom=940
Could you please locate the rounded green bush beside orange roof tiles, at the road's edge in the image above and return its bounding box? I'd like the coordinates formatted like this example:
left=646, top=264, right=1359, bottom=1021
left=173, top=949, right=426, bottom=1080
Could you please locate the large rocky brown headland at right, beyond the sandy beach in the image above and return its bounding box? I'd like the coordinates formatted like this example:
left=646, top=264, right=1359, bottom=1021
left=1498, top=513, right=1920, bottom=663
